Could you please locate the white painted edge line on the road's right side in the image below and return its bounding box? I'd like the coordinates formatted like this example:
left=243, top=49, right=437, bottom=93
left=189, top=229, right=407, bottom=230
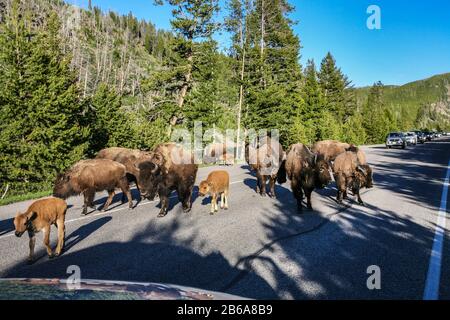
left=423, top=160, right=450, bottom=300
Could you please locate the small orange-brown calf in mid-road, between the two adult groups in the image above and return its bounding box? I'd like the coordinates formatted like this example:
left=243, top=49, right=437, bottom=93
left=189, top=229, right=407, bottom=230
left=199, top=170, right=230, bottom=214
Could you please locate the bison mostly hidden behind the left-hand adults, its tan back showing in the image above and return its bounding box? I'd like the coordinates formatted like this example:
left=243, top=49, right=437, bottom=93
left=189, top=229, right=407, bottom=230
left=95, top=147, right=152, bottom=202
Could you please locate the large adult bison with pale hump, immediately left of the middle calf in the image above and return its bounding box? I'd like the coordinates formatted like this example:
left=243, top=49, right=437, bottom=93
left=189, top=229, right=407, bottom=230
left=136, top=143, right=198, bottom=217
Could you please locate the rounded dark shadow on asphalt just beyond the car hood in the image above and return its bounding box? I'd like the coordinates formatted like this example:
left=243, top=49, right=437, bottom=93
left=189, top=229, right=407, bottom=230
left=2, top=215, right=276, bottom=298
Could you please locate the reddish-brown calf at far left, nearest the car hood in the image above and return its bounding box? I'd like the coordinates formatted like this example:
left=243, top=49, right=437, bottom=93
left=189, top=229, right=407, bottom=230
left=14, top=198, right=67, bottom=263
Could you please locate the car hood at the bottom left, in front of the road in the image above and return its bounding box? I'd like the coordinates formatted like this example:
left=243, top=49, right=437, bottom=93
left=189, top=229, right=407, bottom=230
left=0, top=278, right=245, bottom=300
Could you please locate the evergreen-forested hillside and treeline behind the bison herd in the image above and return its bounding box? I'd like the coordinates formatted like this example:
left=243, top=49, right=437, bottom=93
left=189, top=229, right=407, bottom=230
left=0, top=0, right=450, bottom=194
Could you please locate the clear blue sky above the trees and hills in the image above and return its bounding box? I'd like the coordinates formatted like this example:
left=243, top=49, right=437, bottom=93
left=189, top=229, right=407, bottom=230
left=68, top=0, right=450, bottom=86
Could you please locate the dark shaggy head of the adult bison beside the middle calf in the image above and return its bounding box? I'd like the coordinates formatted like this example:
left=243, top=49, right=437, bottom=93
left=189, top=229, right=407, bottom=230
left=135, top=156, right=163, bottom=200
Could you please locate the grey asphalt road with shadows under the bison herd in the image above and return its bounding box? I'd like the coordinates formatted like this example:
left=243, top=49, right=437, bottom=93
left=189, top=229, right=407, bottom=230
left=0, top=138, right=450, bottom=299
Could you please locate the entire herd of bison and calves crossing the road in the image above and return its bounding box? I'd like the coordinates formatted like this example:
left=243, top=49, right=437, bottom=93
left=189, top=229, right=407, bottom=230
left=14, top=138, right=372, bottom=262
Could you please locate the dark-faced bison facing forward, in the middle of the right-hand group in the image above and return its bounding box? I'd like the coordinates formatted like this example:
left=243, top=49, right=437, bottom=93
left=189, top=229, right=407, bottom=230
left=279, top=143, right=331, bottom=211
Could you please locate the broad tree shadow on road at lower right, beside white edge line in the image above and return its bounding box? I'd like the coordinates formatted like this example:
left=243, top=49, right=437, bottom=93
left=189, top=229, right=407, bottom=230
left=222, top=185, right=442, bottom=299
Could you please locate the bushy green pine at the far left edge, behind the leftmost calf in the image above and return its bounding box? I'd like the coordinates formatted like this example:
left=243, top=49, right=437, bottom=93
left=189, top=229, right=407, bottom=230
left=0, top=5, right=89, bottom=192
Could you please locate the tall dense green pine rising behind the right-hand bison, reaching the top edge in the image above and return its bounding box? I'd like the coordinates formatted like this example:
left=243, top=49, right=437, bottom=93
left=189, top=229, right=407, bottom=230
left=245, top=0, right=302, bottom=145
